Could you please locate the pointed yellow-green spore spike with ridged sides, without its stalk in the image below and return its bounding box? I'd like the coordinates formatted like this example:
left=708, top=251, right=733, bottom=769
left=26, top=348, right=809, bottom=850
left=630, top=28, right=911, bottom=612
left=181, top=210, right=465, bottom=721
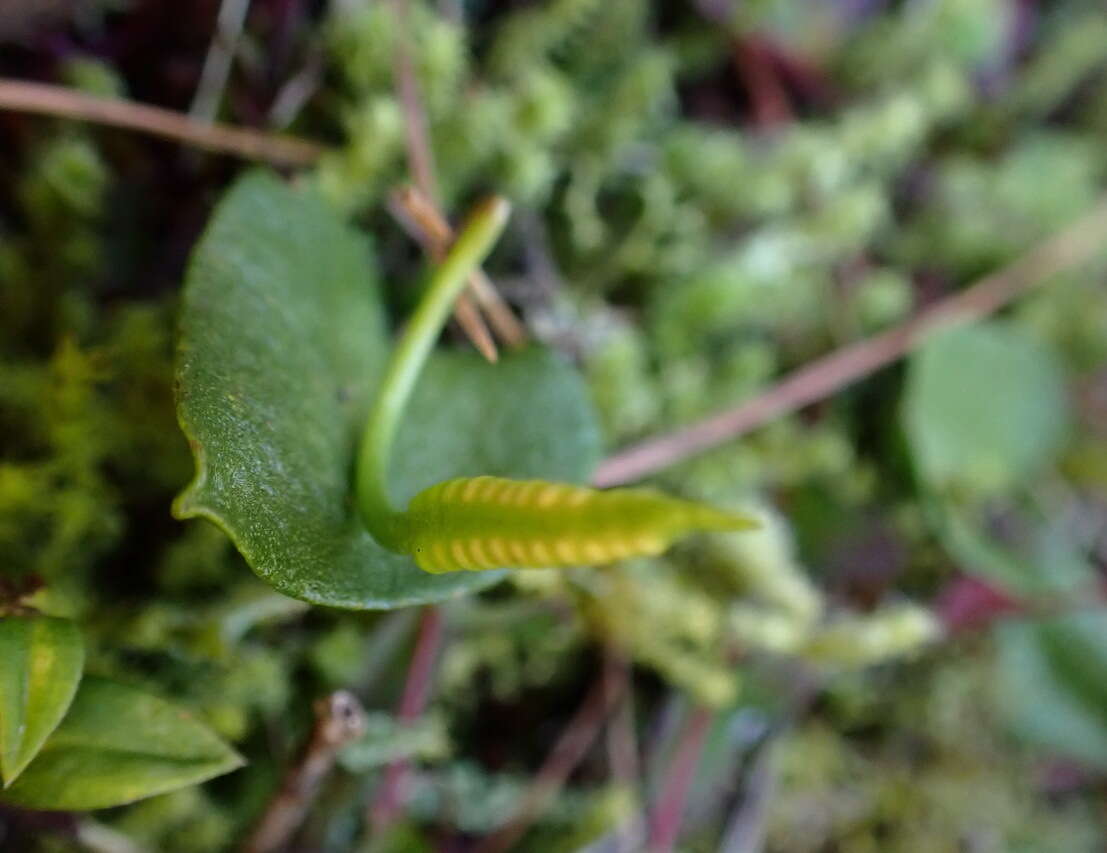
left=396, top=477, right=757, bottom=572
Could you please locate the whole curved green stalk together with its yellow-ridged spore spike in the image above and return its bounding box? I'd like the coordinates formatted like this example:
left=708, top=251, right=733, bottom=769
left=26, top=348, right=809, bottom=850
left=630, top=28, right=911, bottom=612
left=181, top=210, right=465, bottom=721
left=355, top=198, right=757, bottom=572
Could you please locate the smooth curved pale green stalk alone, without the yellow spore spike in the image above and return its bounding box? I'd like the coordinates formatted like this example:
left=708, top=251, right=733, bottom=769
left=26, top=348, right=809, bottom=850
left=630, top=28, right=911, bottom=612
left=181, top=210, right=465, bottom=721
left=356, top=197, right=510, bottom=548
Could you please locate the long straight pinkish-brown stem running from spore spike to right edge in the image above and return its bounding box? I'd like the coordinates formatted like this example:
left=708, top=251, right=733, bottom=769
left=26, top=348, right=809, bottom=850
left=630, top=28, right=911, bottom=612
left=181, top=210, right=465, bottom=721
left=594, top=194, right=1107, bottom=487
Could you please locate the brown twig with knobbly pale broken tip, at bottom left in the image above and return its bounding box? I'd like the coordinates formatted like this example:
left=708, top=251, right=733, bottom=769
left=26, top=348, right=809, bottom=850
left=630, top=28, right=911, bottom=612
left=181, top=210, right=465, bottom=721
left=242, top=690, right=365, bottom=853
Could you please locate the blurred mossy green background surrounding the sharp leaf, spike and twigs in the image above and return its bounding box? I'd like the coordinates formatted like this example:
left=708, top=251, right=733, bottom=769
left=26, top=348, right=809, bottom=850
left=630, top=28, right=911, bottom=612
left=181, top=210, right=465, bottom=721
left=0, top=0, right=1107, bottom=853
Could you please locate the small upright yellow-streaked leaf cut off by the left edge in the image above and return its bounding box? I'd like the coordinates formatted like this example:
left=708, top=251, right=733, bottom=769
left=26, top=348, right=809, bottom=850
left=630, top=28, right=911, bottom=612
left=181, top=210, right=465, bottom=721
left=0, top=615, right=84, bottom=788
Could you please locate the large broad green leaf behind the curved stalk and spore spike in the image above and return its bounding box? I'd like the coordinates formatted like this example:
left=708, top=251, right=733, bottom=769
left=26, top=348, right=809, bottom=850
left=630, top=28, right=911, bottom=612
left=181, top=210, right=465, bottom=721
left=175, top=173, right=599, bottom=610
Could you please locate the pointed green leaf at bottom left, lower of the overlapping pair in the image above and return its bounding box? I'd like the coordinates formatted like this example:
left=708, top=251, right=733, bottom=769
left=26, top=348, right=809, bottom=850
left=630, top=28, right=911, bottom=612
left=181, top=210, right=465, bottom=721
left=0, top=676, right=242, bottom=810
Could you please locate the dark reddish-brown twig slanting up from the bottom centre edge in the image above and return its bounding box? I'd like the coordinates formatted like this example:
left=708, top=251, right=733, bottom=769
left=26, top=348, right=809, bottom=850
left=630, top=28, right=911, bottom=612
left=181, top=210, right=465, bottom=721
left=475, top=659, right=628, bottom=853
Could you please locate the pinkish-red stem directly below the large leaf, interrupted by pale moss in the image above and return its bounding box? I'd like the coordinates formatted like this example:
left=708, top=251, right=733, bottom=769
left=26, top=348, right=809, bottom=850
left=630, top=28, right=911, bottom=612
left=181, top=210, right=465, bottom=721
left=366, top=605, right=443, bottom=836
